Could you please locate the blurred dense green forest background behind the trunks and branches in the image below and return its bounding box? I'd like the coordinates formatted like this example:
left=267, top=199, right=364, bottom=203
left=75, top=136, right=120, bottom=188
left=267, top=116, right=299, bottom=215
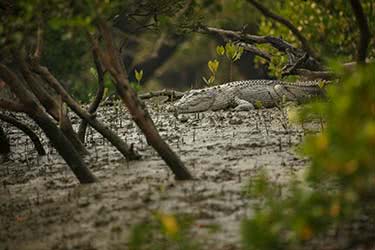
left=2, top=0, right=375, bottom=101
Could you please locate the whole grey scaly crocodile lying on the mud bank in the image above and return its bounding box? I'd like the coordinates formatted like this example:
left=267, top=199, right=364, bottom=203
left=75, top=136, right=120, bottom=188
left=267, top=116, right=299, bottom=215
left=174, top=80, right=325, bottom=113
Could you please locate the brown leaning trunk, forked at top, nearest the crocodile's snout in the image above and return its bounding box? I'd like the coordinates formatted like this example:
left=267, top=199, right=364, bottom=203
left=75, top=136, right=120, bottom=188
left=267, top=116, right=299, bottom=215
left=91, top=21, right=192, bottom=180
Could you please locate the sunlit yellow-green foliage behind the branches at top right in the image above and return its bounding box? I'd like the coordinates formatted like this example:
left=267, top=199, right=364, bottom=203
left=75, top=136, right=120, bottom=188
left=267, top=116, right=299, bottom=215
left=257, top=0, right=375, bottom=74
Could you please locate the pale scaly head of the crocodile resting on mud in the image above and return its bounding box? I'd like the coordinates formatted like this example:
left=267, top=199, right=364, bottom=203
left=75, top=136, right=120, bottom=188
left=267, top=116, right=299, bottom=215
left=174, top=89, right=216, bottom=113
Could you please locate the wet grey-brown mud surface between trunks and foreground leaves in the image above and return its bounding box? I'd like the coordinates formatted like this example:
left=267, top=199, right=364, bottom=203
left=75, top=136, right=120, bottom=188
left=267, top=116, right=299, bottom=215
left=0, top=100, right=374, bottom=250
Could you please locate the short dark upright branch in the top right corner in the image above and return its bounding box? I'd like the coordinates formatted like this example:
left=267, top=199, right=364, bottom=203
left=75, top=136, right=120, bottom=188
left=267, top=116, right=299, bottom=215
left=350, top=0, right=371, bottom=64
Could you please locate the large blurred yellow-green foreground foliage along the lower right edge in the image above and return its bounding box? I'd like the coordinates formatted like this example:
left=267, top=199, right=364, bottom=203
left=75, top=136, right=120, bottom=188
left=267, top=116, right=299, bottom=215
left=242, top=66, right=375, bottom=249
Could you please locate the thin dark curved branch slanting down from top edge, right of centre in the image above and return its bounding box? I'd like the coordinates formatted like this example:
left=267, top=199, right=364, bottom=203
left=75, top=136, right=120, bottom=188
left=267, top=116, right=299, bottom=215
left=247, top=0, right=317, bottom=58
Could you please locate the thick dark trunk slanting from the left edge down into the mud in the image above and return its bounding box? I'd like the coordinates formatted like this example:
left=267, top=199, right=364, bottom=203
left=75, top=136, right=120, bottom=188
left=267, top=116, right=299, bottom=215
left=0, top=64, right=96, bottom=183
